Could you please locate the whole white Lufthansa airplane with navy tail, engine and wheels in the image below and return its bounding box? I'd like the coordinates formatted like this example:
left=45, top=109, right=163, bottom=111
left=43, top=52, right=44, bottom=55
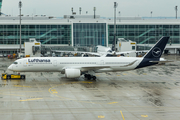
left=8, top=37, right=172, bottom=80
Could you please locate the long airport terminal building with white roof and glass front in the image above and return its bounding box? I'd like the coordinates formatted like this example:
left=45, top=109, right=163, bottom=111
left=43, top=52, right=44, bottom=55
left=0, top=15, right=180, bottom=54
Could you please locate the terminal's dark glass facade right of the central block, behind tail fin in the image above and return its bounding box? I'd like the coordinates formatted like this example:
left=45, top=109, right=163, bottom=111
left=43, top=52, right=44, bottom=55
left=108, top=25, right=180, bottom=44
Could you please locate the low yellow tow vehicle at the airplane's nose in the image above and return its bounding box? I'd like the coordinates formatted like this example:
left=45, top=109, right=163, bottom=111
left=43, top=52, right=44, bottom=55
left=1, top=73, right=26, bottom=80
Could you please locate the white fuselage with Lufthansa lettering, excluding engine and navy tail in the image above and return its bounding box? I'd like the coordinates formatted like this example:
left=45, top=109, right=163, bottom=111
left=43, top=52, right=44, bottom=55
left=8, top=57, right=143, bottom=72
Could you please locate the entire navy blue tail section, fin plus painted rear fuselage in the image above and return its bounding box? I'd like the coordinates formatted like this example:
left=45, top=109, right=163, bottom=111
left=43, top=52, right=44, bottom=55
left=136, top=37, right=170, bottom=68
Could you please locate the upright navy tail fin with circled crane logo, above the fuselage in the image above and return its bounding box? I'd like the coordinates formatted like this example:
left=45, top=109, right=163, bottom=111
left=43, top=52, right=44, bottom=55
left=144, top=37, right=169, bottom=59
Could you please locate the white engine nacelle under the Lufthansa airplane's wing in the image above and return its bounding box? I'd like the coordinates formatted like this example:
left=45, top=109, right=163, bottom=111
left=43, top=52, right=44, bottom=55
left=65, top=69, right=81, bottom=78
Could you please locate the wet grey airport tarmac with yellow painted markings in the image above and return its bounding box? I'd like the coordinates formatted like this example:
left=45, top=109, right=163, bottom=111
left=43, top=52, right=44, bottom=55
left=0, top=55, right=180, bottom=120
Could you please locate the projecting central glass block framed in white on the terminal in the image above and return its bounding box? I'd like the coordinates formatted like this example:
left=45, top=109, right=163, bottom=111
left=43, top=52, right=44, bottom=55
left=73, top=23, right=106, bottom=46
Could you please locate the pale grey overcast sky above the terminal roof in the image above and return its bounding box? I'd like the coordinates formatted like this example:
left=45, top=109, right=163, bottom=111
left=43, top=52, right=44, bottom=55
left=1, top=0, right=180, bottom=17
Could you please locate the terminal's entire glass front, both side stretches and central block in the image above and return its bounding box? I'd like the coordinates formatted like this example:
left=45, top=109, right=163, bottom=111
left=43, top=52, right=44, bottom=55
left=0, top=23, right=180, bottom=46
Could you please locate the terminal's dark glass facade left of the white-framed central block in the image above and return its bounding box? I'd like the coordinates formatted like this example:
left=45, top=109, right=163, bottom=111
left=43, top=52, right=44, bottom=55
left=0, top=25, right=71, bottom=45
